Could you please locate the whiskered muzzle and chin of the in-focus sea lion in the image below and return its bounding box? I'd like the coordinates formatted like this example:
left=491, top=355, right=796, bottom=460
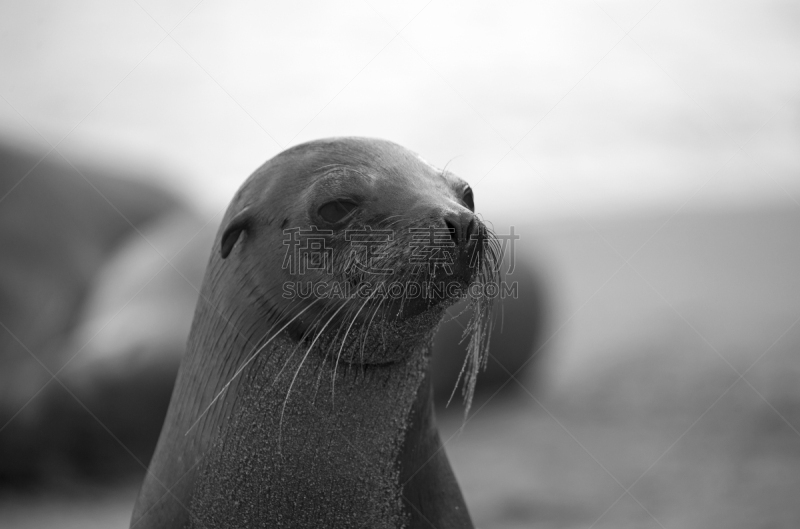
left=276, top=213, right=500, bottom=369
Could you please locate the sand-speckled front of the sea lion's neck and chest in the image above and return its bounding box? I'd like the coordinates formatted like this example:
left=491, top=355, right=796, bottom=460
left=191, top=330, right=428, bottom=528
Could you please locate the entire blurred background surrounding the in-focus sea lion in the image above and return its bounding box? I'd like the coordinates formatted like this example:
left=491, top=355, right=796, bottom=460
left=0, top=0, right=800, bottom=528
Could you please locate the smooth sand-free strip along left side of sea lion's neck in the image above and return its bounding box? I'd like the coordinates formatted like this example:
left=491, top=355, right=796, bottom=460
left=131, top=253, right=282, bottom=528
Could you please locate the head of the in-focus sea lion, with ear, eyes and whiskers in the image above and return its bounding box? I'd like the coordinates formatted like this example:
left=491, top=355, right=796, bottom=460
left=212, top=138, right=497, bottom=372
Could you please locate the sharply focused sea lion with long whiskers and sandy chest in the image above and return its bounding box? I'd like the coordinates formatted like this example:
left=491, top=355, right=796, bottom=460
left=131, top=138, right=500, bottom=528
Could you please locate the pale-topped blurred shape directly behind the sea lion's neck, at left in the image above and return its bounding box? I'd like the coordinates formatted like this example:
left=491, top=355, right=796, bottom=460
left=52, top=210, right=216, bottom=477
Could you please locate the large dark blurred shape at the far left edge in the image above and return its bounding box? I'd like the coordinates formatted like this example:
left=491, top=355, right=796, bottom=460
left=0, top=142, right=182, bottom=482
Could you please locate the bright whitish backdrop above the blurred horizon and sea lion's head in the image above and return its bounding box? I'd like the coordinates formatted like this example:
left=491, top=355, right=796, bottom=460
left=0, top=0, right=800, bottom=218
